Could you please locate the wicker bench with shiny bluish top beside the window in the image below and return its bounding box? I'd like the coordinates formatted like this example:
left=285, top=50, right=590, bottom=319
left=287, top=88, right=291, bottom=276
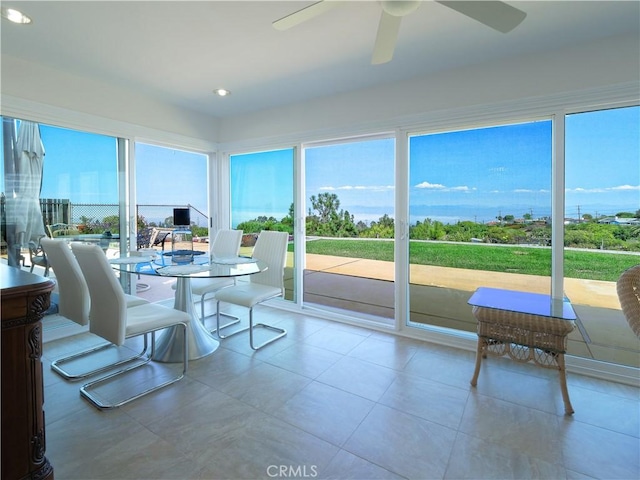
left=469, top=287, right=576, bottom=415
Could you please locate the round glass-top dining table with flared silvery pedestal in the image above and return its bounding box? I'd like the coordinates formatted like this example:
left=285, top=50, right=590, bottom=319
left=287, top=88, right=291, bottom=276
left=109, top=252, right=267, bottom=362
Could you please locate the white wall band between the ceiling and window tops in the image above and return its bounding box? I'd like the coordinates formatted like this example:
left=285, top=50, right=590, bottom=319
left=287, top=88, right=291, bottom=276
left=1, top=36, right=640, bottom=149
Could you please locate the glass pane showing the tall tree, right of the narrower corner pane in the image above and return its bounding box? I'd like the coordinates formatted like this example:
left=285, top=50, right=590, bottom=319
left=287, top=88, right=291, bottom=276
left=304, top=138, right=395, bottom=326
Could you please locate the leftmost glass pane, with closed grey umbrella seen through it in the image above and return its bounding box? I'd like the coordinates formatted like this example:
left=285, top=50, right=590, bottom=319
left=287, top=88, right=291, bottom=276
left=2, top=118, right=121, bottom=273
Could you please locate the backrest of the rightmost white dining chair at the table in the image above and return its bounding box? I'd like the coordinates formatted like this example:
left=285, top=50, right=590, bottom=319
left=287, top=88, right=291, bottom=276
left=249, top=230, right=289, bottom=295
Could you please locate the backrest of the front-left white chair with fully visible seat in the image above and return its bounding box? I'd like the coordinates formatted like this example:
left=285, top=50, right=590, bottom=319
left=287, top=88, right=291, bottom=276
left=71, top=243, right=127, bottom=345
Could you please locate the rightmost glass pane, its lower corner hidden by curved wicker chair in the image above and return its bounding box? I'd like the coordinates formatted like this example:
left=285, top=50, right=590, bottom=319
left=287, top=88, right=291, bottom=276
left=564, top=107, right=640, bottom=367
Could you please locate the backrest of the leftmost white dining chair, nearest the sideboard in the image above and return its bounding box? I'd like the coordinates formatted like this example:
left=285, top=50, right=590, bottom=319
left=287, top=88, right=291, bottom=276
left=40, top=237, right=91, bottom=325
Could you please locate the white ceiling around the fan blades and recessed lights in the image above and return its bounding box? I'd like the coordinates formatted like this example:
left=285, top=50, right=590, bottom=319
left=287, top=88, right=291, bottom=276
left=1, top=0, right=640, bottom=117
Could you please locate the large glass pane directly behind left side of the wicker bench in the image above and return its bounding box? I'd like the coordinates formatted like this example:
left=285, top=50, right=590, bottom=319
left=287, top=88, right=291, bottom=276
left=409, top=121, right=552, bottom=332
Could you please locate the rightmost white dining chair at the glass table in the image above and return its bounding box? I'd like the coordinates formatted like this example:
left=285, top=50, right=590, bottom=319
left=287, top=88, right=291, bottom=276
left=215, top=230, right=289, bottom=350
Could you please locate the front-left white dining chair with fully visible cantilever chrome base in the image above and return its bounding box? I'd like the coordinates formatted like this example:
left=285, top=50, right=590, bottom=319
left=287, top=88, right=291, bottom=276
left=71, top=243, right=190, bottom=409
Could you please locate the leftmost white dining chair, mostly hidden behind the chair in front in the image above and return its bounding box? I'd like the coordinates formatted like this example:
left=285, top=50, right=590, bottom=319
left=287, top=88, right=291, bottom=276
left=40, top=237, right=149, bottom=381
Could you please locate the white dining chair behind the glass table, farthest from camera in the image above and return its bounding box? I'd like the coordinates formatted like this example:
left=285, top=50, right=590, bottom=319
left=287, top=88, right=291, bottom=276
left=171, top=230, right=242, bottom=328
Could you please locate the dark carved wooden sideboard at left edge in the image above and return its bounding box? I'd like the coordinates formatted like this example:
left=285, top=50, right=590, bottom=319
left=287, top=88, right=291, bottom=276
left=0, top=264, right=54, bottom=480
